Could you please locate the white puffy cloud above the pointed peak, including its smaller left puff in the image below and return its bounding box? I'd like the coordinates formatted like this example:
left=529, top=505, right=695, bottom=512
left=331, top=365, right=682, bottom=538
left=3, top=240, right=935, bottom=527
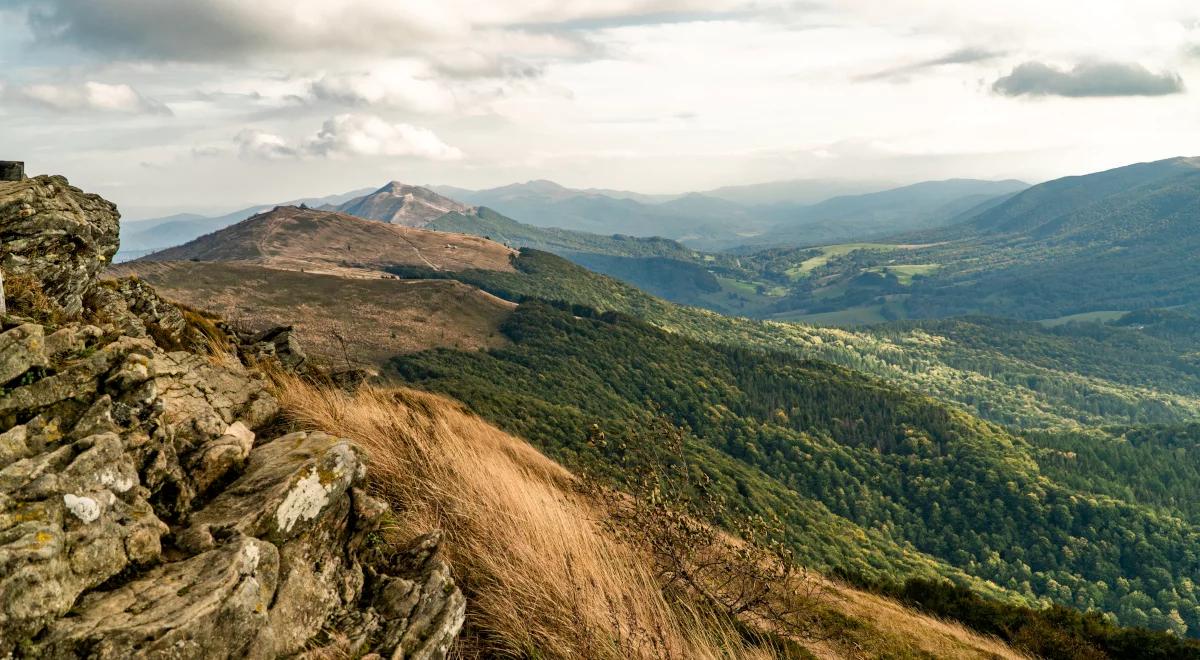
left=234, top=114, right=462, bottom=161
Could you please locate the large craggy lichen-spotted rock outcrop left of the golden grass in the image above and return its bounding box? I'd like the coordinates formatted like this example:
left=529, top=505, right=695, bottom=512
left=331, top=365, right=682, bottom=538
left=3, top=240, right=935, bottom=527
left=0, top=180, right=464, bottom=658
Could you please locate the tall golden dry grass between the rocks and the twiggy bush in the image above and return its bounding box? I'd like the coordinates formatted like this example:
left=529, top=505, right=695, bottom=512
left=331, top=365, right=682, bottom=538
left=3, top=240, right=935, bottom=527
left=280, top=379, right=776, bottom=659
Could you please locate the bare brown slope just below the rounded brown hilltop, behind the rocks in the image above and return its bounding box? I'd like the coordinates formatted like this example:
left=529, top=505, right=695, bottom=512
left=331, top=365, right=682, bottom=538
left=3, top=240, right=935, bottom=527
left=106, top=260, right=514, bottom=370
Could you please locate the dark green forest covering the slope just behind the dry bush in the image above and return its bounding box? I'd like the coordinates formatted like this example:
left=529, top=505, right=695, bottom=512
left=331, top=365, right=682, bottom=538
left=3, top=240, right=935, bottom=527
left=390, top=302, right=1200, bottom=634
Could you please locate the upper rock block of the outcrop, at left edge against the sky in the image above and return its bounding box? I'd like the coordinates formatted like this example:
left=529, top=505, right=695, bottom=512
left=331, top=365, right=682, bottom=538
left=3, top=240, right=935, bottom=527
left=0, top=176, right=120, bottom=317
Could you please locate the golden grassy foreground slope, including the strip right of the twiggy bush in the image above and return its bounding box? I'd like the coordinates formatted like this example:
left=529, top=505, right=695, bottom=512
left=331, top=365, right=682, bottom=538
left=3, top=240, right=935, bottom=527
left=282, top=383, right=1024, bottom=659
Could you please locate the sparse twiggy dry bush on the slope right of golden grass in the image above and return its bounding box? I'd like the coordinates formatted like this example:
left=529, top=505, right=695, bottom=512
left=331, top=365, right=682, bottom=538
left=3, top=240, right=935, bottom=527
left=580, top=416, right=829, bottom=642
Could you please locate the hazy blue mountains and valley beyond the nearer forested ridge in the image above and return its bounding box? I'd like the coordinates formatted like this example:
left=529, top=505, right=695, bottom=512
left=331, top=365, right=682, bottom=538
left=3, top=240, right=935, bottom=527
left=117, top=158, right=1200, bottom=324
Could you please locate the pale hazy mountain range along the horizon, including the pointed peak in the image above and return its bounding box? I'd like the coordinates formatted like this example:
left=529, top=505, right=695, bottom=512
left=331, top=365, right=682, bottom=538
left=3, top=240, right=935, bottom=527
left=121, top=180, right=1024, bottom=259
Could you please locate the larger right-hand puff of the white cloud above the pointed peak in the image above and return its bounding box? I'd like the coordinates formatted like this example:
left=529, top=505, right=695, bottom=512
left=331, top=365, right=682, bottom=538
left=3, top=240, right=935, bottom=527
left=305, top=114, right=462, bottom=161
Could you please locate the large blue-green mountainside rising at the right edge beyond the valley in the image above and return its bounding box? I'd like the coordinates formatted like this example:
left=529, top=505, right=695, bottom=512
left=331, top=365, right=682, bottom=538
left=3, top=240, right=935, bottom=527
left=748, top=158, right=1200, bottom=323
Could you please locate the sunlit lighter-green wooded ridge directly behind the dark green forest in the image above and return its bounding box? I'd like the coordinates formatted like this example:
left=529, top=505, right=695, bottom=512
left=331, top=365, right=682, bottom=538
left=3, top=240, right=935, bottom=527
left=386, top=250, right=1200, bottom=427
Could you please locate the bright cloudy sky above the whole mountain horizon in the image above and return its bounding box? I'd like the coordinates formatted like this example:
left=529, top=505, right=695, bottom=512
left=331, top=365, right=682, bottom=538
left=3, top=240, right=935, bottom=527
left=0, top=0, right=1200, bottom=218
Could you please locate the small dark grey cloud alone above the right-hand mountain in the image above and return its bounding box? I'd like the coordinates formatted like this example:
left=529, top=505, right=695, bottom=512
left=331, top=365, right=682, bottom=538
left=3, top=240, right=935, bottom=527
left=991, top=61, right=1183, bottom=97
